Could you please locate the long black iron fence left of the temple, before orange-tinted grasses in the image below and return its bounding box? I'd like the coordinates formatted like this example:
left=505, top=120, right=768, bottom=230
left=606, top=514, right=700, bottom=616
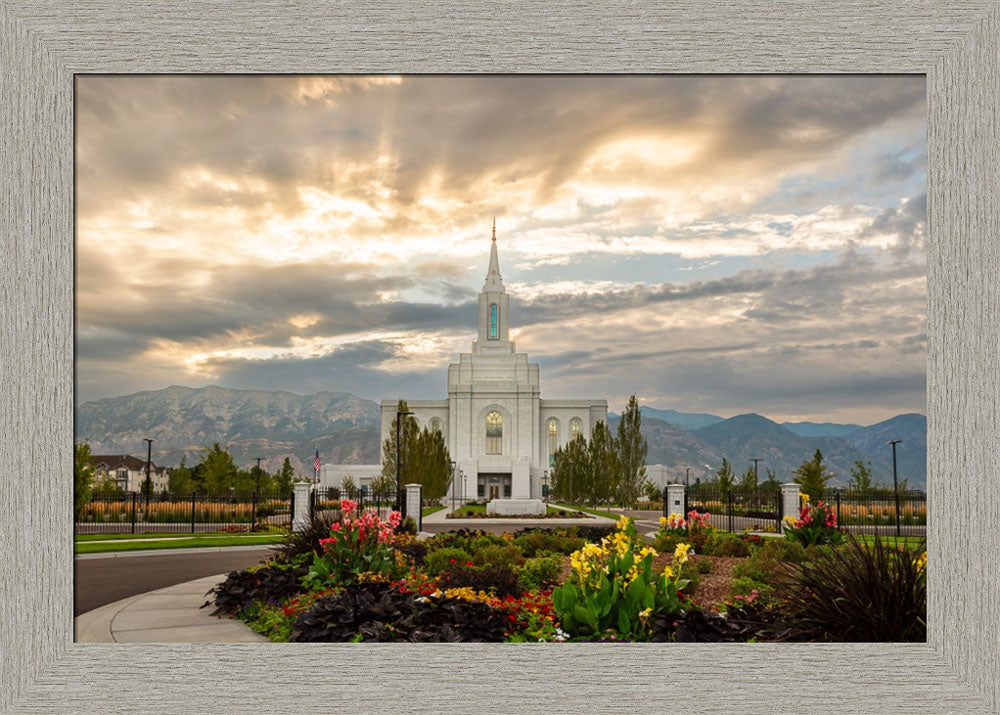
left=76, top=492, right=292, bottom=534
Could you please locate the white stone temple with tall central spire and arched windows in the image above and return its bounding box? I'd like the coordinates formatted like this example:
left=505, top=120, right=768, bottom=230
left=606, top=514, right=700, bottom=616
left=321, top=230, right=608, bottom=510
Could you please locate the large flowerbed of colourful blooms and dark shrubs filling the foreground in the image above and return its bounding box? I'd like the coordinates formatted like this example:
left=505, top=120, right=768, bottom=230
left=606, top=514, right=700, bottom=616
left=205, top=499, right=926, bottom=642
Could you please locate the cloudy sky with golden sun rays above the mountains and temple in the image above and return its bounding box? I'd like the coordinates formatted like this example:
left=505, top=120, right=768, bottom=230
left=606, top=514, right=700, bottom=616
left=76, top=76, right=926, bottom=424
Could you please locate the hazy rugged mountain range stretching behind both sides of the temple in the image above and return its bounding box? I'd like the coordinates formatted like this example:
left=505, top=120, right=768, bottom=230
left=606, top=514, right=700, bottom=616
left=76, top=386, right=927, bottom=488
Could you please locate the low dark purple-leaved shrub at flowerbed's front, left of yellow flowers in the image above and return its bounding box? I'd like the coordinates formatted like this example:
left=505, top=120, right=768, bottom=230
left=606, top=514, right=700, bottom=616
left=289, top=582, right=508, bottom=643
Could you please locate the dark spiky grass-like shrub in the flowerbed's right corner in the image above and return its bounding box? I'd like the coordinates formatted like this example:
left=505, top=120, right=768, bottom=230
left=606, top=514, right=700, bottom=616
left=777, top=536, right=927, bottom=642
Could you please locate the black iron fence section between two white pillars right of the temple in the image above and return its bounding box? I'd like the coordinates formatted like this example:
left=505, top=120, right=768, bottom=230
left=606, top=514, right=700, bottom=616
left=684, top=484, right=782, bottom=533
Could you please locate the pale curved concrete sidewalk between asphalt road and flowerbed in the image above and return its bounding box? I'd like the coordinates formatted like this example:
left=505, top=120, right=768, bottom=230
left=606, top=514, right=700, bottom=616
left=75, top=574, right=270, bottom=643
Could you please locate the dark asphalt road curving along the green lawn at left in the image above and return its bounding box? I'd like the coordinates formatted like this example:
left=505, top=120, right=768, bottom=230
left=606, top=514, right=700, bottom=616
left=73, top=547, right=274, bottom=616
